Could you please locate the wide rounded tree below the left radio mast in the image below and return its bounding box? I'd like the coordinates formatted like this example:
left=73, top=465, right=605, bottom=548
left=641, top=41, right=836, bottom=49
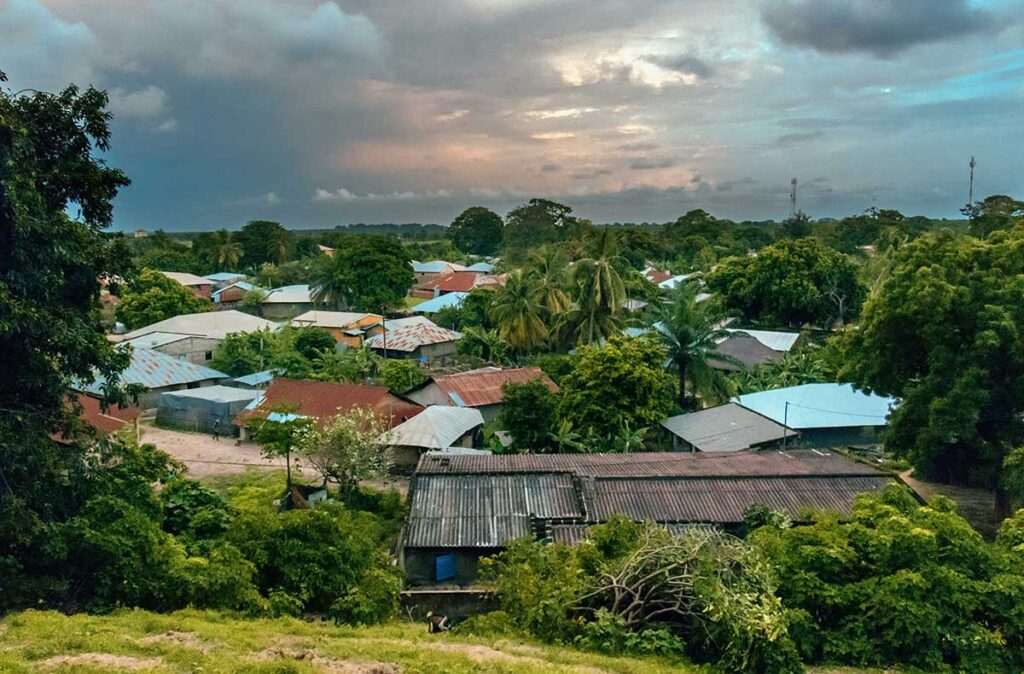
left=708, top=239, right=866, bottom=327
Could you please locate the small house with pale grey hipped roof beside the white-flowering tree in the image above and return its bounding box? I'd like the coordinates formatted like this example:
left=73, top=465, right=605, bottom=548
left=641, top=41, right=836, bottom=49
left=384, top=405, right=483, bottom=472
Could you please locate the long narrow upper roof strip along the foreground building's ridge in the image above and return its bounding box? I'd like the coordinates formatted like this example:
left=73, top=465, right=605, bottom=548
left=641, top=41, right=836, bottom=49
left=416, top=450, right=879, bottom=477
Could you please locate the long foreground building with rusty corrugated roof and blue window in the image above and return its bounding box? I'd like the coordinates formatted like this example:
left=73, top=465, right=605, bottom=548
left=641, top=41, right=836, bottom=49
left=400, top=450, right=895, bottom=586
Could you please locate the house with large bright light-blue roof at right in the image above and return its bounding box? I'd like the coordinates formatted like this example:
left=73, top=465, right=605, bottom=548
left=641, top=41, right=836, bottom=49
left=732, top=384, right=896, bottom=448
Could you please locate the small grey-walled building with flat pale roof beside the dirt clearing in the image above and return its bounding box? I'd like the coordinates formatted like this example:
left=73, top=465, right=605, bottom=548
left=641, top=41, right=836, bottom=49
left=157, top=386, right=257, bottom=435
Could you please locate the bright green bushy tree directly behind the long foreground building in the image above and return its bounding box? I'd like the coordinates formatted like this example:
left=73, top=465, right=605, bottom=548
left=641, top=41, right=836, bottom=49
left=559, top=337, right=675, bottom=437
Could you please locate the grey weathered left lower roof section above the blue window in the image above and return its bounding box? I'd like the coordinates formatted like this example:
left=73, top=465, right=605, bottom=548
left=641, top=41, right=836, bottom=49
left=404, top=475, right=583, bottom=548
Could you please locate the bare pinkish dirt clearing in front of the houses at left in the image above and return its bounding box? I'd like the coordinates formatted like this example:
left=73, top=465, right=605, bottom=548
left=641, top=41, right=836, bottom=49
left=141, top=423, right=285, bottom=477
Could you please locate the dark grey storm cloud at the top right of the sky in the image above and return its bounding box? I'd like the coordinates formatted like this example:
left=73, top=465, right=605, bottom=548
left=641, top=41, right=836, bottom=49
left=761, top=0, right=996, bottom=56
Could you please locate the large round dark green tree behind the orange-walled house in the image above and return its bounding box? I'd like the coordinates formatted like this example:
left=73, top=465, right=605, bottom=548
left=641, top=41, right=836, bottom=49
left=313, top=236, right=416, bottom=312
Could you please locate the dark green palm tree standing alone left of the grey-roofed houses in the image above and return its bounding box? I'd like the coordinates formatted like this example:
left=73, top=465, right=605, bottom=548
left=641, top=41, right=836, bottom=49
left=653, top=283, right=740, bottom=410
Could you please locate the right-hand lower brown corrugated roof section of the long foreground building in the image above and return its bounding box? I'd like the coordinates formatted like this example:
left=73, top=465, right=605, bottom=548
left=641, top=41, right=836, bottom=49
left=584, top=474, right=892, bottom=524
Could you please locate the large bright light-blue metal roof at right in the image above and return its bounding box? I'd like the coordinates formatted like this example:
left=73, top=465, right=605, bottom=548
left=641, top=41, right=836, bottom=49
left=732, top=384, right=896, bottom=430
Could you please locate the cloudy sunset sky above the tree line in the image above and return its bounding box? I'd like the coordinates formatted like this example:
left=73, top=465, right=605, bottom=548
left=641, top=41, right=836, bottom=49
left=0, top=0, right=1024, bottom=230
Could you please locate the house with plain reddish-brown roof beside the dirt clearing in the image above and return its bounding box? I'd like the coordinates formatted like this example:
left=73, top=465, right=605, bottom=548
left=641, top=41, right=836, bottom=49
left=234, top=377, right=423, bottom=439
